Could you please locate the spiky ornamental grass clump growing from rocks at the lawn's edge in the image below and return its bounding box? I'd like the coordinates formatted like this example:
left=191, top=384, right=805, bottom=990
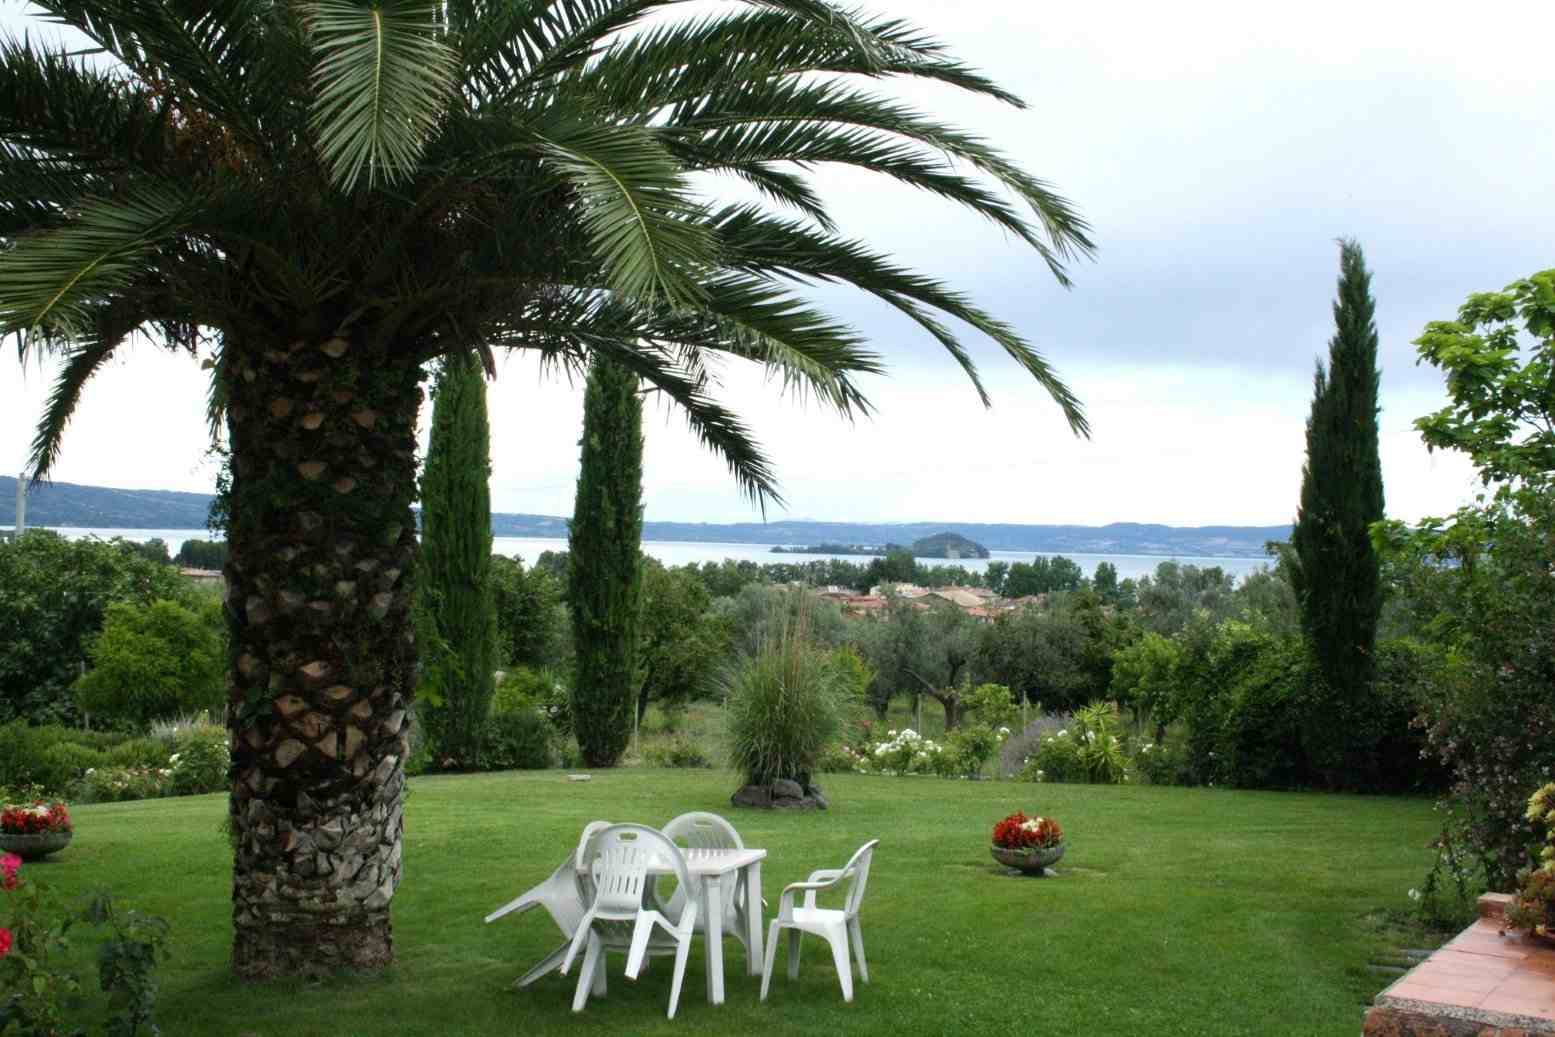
left=723, top=608, right=855, bottom=785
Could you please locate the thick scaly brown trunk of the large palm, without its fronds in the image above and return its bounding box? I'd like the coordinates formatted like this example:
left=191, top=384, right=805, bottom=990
left=222, top=337, right=421, bottom=978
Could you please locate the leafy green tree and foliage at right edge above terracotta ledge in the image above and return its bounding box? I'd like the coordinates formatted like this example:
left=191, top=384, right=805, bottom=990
left=1375, top=271, right=1555, bottom=889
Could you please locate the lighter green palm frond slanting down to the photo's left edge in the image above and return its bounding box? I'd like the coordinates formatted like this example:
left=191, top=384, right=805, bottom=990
left=0, top=185, right=193, bottom=334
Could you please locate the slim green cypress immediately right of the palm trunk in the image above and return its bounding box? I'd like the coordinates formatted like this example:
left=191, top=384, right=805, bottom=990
left=420, top=353, right=498, bottom=768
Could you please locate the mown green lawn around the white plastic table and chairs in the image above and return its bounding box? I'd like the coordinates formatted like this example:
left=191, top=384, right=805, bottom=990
left=30, top=768, right=1434, bottom=1037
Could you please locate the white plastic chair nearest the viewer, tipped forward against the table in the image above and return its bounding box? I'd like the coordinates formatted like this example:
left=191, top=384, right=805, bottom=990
left=561, top=824, right=697, bottom=1018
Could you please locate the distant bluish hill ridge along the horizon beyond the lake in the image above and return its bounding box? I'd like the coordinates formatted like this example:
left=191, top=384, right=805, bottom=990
left=0, top=476, right=1291, bottom=558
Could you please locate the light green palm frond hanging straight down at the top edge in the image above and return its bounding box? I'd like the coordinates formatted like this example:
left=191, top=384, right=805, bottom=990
left=303, top=0, right=459, bottom=191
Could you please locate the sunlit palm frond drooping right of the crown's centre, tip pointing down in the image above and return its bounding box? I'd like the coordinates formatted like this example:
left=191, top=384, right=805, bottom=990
left=536, top=121, right=712, bottom=305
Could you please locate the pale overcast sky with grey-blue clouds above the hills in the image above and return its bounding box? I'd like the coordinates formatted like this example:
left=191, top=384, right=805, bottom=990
left=0, top=0, right=1555, bottom=525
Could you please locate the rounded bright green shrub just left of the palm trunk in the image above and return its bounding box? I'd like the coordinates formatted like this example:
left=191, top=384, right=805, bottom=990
left=75, top=600, right=225, bottom=729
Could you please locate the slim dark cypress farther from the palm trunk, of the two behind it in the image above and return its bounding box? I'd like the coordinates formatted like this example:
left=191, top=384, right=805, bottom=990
left=568, top=359, right=642, bottom=766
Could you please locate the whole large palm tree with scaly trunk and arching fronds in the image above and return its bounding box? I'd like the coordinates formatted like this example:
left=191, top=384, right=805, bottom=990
left=0, top=0, right=1090, bottom=976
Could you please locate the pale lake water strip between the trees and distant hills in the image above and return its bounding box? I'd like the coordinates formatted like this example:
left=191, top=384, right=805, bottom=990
left=42, top=525, right=1269, bottom=580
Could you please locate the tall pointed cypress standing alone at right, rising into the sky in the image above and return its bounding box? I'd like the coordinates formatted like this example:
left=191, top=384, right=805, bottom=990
left=1291, top=241, right=1382, bottom=784
